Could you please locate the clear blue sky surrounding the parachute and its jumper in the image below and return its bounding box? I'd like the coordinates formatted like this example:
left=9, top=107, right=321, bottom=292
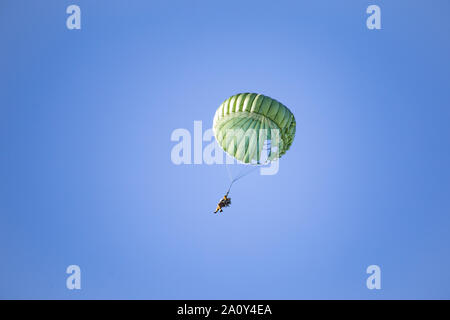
left=0, top=0, right=450, bottom=299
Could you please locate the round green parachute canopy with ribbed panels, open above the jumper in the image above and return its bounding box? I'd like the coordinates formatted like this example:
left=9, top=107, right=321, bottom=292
left=213, top=93, right=296, bottom=165
